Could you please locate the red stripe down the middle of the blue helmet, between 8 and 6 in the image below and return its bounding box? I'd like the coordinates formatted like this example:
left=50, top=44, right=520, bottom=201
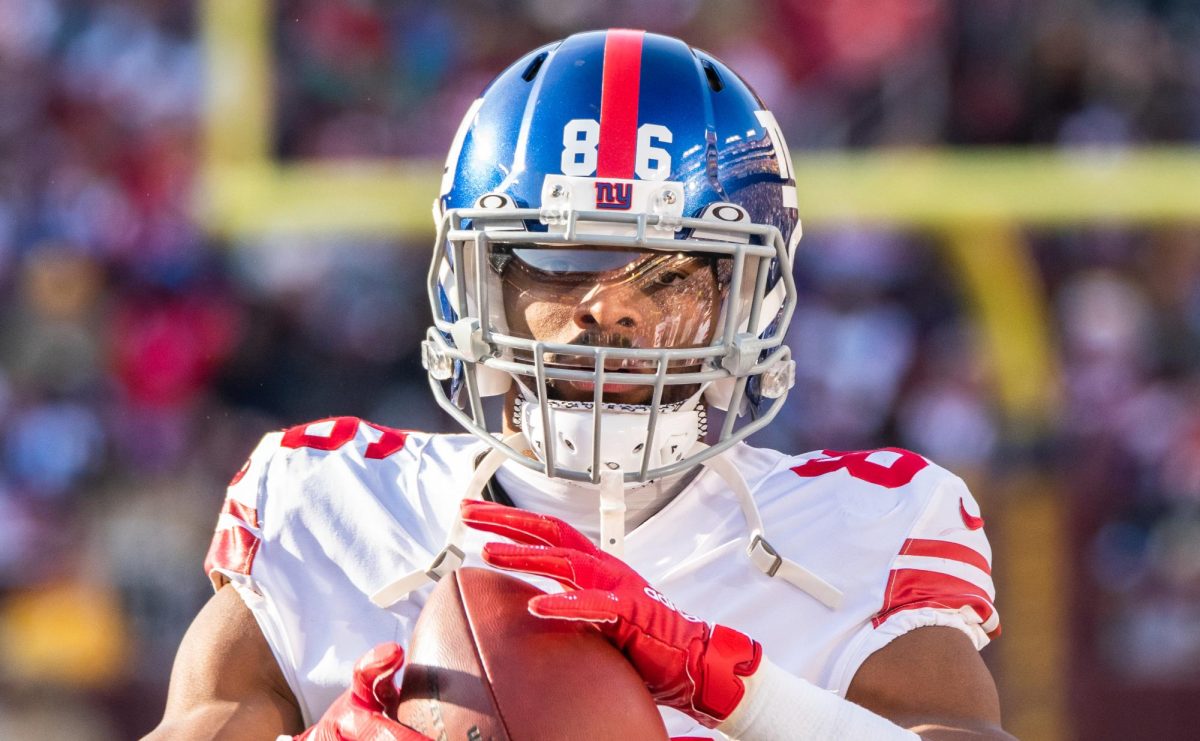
left=596, top=29, right=646, bottom=179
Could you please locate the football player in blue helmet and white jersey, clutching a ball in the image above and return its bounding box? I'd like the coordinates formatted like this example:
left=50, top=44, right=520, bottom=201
left=152, top=30, right=1009, bottom=740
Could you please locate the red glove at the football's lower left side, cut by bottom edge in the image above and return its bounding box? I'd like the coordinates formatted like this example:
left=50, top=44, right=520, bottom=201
left=295, top=643, right=431, bottom=741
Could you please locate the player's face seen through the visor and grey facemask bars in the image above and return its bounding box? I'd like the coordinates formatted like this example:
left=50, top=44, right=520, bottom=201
left=500, top=245, right=728, bottom=404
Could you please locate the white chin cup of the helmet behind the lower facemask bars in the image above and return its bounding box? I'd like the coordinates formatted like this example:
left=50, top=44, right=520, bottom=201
left=516, top=393, right=708, bottom=474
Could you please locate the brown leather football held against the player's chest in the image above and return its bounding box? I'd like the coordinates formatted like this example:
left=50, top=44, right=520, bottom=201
left=397, top=568, right=667, bottom=741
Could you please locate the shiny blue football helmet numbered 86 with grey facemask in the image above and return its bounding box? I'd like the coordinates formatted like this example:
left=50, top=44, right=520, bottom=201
left=422, top=30, right=800, bottom=482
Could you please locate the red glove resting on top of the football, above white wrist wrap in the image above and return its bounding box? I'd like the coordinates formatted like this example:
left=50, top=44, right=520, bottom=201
left=462, top=500, right=762, bottom=728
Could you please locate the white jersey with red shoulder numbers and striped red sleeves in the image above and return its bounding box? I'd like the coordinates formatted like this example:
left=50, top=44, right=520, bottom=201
left=205, top=417, right=1000, bottom=737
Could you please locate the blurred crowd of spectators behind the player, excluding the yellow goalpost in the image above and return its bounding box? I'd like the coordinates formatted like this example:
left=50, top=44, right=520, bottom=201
left=0, top=0, right=1200, bottom=740
